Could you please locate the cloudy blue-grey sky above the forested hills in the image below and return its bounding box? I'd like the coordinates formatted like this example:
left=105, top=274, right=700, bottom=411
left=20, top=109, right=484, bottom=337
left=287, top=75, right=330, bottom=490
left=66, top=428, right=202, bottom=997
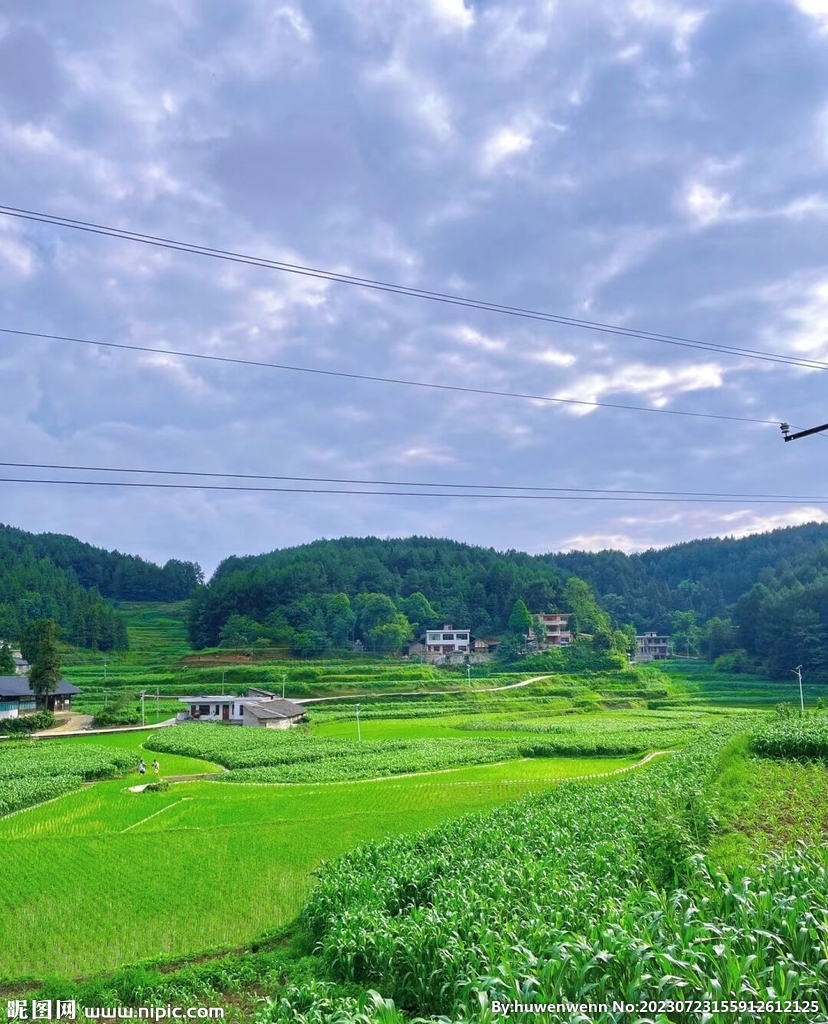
left=0, top=0, right=828, bottom=573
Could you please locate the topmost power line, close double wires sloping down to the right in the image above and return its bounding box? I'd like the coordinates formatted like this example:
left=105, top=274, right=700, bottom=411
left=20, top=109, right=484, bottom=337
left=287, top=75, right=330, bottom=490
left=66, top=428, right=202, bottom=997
left=0, top=199, right=828, bottom=370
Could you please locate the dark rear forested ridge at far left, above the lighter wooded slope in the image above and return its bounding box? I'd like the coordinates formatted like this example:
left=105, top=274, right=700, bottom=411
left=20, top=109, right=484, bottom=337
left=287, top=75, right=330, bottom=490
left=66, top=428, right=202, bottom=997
left=0, top=523, right=202, bottom=601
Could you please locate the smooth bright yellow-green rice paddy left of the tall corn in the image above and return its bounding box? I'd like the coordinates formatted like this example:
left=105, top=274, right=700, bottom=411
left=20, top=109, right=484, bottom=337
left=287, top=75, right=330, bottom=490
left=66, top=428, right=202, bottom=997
left=0, top=753, right=629, bottom=980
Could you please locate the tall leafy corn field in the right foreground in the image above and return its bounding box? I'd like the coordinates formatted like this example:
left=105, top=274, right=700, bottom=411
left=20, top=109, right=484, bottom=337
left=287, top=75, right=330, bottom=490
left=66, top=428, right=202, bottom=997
left=303, top=723, right=828, bottom=1022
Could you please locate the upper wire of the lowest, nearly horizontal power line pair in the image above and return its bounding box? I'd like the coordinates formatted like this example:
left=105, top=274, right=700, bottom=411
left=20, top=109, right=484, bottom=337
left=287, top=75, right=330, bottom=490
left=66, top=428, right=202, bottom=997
left=0, top=462, right=828, bottom=502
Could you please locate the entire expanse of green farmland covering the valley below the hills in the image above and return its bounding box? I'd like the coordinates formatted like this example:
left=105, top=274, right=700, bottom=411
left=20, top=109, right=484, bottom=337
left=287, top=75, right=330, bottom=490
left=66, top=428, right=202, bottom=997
left=0, top=643, right=828, bottom=1024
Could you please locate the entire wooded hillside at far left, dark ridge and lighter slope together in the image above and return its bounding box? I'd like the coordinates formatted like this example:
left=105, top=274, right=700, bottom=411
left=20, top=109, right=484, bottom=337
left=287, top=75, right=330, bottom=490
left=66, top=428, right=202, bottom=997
left=0, top=524, right=202, bottom=650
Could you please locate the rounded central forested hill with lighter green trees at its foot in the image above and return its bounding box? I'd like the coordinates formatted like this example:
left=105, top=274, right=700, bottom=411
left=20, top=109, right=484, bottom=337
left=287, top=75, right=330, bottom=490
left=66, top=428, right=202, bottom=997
left=190, top=537, right=592, bottom=651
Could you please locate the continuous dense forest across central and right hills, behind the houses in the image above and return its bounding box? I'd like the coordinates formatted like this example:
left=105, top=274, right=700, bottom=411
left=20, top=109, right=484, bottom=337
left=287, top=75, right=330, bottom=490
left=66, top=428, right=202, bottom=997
left=189, top=523, right=828, bottom=680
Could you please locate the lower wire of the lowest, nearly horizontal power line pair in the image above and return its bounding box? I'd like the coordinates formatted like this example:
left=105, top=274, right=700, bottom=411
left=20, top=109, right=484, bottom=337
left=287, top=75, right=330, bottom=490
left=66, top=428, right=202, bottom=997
left=0, top=476, right=828, bottom=505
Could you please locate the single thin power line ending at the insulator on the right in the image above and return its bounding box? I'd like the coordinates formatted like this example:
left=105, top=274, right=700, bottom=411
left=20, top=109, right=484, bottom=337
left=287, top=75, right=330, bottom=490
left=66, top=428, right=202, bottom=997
left=0, top=327, right=779, bottom=426
